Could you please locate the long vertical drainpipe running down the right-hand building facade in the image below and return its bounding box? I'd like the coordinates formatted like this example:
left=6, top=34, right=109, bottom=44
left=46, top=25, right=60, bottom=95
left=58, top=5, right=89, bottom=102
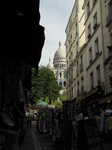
left=100, top=0, right=107, bottom=94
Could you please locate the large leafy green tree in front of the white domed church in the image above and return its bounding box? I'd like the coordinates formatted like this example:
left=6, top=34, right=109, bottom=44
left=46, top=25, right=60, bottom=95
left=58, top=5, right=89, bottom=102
left=30, top=66, right=61, bottom=102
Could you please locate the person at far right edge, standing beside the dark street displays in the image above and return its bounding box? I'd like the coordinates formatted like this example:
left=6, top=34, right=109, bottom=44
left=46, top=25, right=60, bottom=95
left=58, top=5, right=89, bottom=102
left=105, top=113, right=112, bottom=140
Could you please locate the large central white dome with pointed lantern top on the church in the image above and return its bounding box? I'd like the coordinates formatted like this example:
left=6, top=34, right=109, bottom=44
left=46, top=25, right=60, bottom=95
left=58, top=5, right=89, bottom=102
left=54, top=42, right=66, bottom=60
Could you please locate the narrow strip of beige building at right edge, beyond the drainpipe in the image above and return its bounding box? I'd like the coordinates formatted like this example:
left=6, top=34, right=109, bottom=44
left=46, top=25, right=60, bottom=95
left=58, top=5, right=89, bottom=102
left=99, top=0, right=112, bottom=106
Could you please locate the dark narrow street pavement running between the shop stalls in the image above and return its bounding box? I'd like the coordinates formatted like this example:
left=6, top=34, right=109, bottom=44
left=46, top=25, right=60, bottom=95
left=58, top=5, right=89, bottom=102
left=18, top=121, right=112, bottom=150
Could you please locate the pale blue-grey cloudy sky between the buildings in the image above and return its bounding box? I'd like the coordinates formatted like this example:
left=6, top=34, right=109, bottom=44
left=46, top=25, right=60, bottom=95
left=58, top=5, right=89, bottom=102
left=39, top=0, right=75, bottom=66
